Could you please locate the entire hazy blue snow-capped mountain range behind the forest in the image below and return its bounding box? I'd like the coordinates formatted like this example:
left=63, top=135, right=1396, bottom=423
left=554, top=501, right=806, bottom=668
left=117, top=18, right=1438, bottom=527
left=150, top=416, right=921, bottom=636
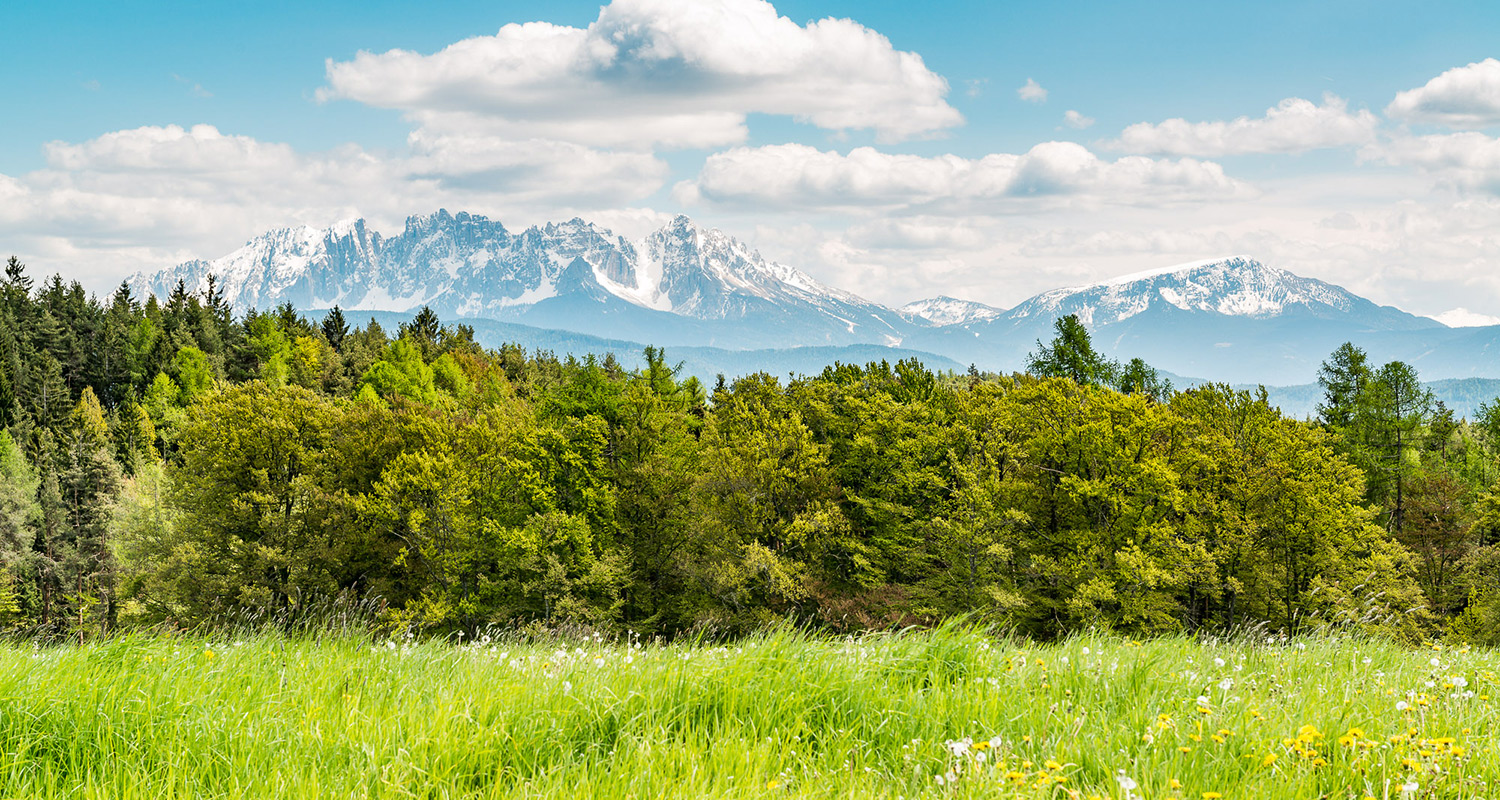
left=131, top=210, right=1500, bottom=386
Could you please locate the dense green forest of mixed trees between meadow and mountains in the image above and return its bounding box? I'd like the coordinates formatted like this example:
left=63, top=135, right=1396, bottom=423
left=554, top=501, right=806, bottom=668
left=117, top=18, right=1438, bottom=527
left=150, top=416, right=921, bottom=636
left=0, top=257, right=1500, bottom=642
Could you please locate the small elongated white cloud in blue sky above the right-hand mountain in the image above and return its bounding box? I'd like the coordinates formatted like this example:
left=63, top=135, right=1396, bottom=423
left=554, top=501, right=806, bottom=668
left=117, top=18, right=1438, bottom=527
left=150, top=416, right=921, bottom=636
left=1106, top=95, right=1380, bottom=158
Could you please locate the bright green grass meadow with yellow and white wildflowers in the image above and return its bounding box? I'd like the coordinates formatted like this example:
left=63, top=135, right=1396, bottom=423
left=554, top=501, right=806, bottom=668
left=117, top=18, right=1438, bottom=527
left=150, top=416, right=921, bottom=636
left=0, top=629, right=1500, bottom=800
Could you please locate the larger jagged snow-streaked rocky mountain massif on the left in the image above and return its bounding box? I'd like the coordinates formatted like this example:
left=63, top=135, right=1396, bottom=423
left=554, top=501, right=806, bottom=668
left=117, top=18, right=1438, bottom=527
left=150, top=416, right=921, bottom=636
left=131, top=210, right=906, bottom=345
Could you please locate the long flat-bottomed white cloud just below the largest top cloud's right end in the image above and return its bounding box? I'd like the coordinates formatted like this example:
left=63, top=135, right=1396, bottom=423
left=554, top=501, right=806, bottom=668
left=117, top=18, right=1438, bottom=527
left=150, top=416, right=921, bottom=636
left=675, top=141, right=1244, bottom=209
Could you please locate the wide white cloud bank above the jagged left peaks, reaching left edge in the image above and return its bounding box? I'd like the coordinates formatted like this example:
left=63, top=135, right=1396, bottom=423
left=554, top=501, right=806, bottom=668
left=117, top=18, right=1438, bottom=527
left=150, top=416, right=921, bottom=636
left=0, top=125, right=668, bottom=272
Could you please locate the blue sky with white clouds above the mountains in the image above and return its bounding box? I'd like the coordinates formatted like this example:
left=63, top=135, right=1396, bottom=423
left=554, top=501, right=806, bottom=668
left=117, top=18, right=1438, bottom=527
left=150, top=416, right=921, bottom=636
left=0, top=0, right=1500, bottom=324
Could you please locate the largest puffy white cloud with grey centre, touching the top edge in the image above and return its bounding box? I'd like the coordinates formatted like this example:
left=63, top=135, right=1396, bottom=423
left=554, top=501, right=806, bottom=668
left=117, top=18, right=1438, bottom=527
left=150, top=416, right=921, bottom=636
left=318, top=0, right=963, bottom=149
